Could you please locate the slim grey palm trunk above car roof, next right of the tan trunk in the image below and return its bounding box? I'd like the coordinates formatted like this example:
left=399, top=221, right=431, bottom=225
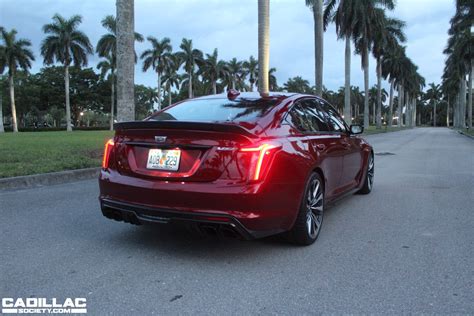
left=305, top=0, right=324, bottom=96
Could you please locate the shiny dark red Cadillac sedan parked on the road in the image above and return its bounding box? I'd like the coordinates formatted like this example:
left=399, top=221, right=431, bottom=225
left=99, top=90, right=374, bottom=245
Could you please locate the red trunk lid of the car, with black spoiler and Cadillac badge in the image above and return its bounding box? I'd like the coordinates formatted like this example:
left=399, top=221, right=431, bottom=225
left=114, top=121, right=258, bottom=182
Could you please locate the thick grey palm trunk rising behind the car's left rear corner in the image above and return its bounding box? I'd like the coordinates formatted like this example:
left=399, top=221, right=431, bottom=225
left=116, top=0, right=135, bottom=122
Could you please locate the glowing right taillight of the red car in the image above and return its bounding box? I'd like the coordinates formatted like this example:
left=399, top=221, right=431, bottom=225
left=240, top=143, right=282, bottom=181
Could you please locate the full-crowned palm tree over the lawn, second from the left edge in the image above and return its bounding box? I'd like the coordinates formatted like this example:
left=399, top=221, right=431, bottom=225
left=41, top=14, right=93, bottom=132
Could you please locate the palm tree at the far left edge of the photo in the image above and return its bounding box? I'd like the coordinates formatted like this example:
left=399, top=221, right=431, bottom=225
left=0, top=28, right=35, bottom=132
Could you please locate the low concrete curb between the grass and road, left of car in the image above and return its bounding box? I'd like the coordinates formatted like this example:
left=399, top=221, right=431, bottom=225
left=0, top=168, right=100, bottom=190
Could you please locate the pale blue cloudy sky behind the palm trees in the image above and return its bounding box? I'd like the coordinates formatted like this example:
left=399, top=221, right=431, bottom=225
left=0, top=0, right=455, bottom=90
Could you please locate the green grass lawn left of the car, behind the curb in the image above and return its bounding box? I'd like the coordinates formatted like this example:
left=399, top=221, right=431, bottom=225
left=0, top=131, right=113, bottom=178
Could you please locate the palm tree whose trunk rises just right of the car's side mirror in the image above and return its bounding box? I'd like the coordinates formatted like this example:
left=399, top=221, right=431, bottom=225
left=352, top=0, right=394, bottom=128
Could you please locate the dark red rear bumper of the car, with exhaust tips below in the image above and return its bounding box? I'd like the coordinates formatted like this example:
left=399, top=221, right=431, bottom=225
left=99, top=170, right=302, bottom=239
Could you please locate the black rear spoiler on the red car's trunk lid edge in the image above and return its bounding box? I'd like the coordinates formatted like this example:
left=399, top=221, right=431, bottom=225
left=114, top=120, right=257, bottom=138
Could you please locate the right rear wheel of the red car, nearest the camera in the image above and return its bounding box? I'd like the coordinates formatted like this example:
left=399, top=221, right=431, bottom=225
left=289, top=173, right=324, bottom=245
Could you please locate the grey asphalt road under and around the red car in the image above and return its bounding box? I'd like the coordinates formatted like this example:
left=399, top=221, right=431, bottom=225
left=0, top=128, right=474, bottom=315
